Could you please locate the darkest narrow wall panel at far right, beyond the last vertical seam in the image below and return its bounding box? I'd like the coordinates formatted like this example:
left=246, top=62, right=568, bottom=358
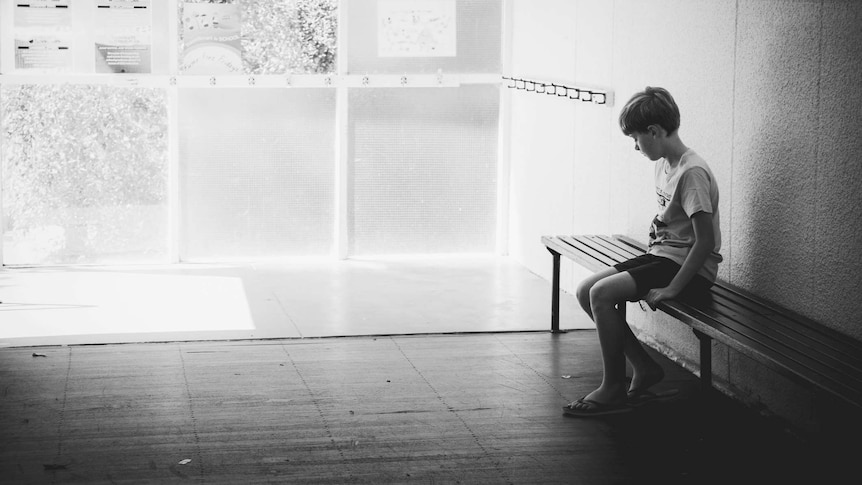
left=806, top=2, right=862, bottom=332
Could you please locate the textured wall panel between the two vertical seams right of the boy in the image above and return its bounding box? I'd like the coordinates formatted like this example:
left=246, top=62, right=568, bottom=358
left=730, top=1, right=820, bottom=326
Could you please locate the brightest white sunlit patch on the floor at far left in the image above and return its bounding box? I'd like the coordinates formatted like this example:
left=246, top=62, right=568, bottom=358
left=0, top=270, right=254, bottom=339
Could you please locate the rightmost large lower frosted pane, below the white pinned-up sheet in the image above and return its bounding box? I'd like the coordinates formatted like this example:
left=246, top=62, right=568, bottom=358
left=349, top=85, right=499, bottom=255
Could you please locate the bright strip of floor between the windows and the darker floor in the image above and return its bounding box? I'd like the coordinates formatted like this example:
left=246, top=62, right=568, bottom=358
left=0, top=256, right=593, bottom=346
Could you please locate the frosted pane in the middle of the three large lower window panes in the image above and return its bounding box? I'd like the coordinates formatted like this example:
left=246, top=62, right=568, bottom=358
left=179, top=88, right=335, bottom=261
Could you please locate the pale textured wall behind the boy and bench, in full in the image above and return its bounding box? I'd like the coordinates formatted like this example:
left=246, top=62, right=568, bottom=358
left=505, top=0, right=862, bottom=432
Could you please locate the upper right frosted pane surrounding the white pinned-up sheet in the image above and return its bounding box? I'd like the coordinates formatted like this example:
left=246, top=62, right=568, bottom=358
left=348, top=0, right=503, bottom=74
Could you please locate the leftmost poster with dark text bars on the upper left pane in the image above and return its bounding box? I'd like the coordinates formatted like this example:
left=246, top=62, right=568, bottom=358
left=12, top=0, right=73, bottom=71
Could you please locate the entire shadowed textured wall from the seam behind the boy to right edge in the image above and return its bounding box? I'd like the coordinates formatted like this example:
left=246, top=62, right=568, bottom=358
left=730, top=1, right=862, bottom=338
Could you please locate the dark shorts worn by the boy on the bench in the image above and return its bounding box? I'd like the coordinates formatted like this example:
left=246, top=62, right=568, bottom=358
left=614, top=254, right=712, bottom=301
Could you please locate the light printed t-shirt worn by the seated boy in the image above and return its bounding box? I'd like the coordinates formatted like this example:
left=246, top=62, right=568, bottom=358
left=647, top=149, right=722, bottom=281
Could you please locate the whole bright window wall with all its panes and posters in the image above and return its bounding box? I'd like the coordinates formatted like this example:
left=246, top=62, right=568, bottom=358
left=0, top=0, right=502, bottom=265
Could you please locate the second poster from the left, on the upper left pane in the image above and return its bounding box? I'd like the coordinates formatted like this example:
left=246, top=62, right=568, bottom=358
left=93, top=0, right=153, bottom=74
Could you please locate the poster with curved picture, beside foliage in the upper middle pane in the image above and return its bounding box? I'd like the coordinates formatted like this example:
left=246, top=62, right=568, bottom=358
left=180, top=3, right=243, bottom=74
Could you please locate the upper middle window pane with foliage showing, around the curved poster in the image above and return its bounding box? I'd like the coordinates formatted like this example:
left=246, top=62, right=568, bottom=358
left=178, top=0, right=338, bottom=74
